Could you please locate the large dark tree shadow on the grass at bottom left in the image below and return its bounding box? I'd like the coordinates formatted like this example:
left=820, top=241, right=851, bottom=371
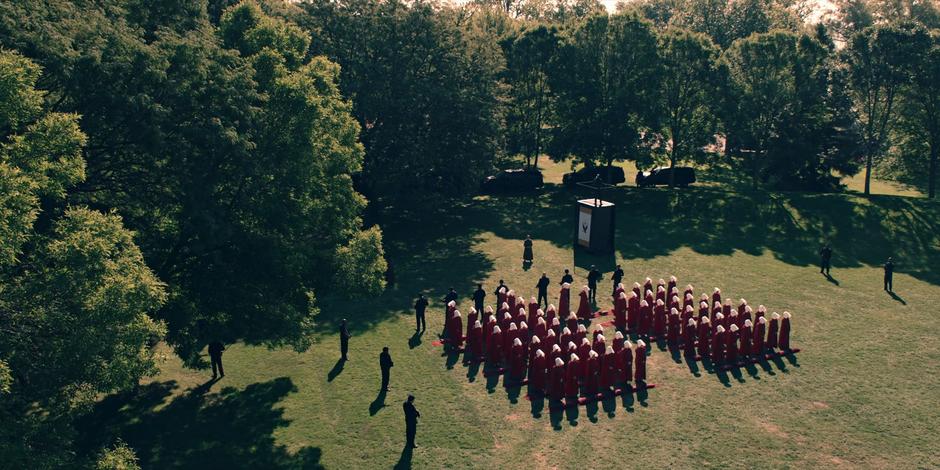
left=78, top=377, right=323, bottom=469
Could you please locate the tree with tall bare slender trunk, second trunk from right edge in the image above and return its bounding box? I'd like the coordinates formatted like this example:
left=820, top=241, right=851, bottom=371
left=842, top=25, right=927, bottom=194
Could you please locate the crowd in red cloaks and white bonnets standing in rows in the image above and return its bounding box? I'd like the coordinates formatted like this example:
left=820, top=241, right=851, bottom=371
left=444, top=277, right=790, bottom=399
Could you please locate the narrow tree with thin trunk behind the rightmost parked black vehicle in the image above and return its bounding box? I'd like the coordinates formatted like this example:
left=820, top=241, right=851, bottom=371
left=659, top=28, right=718, bottom=186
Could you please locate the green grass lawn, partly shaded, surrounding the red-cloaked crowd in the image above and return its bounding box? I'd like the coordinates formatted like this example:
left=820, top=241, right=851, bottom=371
left=83, top=164, right=940, bottom=469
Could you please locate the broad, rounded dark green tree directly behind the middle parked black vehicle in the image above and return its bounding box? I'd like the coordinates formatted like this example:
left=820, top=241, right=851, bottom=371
left=550, top=12, right=661, bottom=169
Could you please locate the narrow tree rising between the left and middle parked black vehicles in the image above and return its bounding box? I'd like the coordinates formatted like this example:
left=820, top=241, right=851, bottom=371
left=506, top=25, right=558, bottom=166
